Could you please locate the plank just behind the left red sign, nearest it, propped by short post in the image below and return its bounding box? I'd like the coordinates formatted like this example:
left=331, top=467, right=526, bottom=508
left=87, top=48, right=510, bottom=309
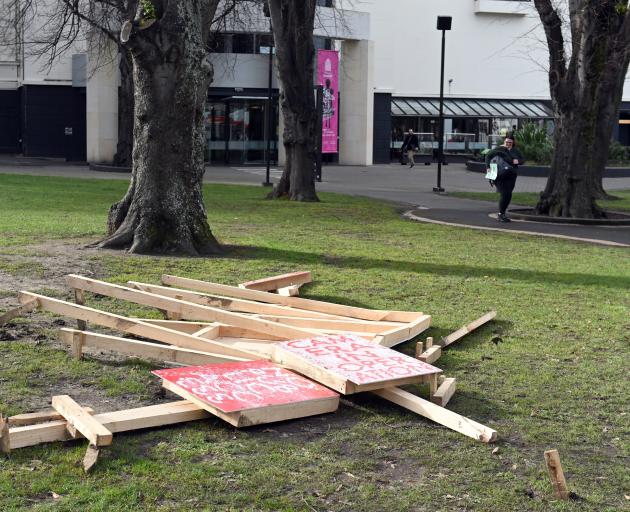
left=59, top=328, right=232, bottom=365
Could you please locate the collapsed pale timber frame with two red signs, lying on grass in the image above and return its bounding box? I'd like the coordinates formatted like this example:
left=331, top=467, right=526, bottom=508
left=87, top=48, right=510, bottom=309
left=0, top=273, right=497, bottom=470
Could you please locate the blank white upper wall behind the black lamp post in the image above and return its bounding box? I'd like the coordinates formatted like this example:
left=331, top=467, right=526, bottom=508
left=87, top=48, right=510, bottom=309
left=355, top=0, right=549, bottom=98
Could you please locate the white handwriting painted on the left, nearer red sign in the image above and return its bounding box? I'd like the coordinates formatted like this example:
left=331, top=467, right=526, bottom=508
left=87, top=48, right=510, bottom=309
left=176, top=368, right=317, bottom=404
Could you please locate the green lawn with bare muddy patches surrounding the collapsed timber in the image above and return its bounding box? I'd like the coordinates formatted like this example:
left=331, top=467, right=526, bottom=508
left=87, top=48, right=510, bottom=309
left=0, top=175, right=630, bottom=512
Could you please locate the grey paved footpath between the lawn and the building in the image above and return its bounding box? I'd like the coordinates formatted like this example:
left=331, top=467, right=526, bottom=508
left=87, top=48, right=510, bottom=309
left=0, top=157, right=630, bottom=247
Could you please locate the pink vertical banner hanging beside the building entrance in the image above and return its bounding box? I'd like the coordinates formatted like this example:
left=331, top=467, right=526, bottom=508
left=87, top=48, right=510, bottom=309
left=317, top=50, right=339, bottom=153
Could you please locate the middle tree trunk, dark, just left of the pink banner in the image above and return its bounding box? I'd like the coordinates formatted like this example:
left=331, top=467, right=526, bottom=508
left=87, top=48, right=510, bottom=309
left=269, top=0, right=319, bottom=201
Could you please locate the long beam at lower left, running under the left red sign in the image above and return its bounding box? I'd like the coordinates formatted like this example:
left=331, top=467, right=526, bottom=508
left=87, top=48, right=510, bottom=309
left=9, top=400, right=210, bottom=449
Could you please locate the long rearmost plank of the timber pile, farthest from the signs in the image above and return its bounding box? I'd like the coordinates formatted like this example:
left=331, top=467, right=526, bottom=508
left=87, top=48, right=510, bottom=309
left=162, top=274, right=417, bottom=322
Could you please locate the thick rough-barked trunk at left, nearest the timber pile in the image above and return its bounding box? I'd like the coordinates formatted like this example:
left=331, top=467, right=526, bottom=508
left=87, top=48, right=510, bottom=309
left=100, top=0, right=221, bottom=255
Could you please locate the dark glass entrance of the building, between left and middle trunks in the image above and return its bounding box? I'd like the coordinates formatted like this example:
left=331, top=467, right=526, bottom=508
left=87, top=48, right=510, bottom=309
left=205, top=98, right=278, bottom=165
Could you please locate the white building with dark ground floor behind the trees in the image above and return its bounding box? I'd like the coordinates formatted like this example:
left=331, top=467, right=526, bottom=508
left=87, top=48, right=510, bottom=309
left=0, top=0, right=630, bottom=165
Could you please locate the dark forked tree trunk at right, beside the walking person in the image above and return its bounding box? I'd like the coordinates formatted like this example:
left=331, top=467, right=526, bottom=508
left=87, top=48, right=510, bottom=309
left=535, top=0, right=630, bottom=218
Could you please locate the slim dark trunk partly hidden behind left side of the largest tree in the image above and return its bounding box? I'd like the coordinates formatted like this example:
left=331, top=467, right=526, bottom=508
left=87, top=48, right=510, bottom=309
left=114, top=47, right=133, bottom=167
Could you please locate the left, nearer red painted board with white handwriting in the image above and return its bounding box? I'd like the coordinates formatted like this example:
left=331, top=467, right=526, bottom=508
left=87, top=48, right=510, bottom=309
left=153, top=361, right=337, bottom=413
